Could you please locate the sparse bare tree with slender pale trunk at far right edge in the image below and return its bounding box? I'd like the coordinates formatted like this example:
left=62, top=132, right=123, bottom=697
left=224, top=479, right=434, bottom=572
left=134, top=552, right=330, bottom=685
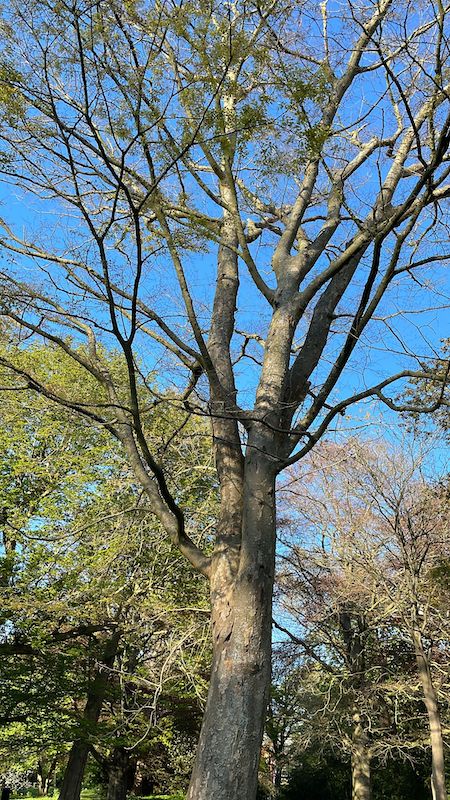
left=342, top=446, right=450, bottom=800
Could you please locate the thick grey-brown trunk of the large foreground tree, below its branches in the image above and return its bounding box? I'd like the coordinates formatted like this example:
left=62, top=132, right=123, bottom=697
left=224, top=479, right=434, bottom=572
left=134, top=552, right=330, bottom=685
left=187, top=450, right=275, bottom=800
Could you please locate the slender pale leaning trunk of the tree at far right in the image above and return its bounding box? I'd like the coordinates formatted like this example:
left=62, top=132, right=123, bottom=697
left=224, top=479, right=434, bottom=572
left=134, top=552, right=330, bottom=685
left=413, top=629, right=447, bottom=800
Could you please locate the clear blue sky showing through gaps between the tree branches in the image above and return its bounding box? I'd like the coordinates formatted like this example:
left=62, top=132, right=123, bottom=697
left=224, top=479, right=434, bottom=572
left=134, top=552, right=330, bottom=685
left=0, top=2, right=450, bottom=476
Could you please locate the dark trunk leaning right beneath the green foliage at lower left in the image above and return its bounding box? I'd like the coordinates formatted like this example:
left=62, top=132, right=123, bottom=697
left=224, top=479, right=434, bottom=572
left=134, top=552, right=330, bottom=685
left=59, top=633, right=119, bottom=800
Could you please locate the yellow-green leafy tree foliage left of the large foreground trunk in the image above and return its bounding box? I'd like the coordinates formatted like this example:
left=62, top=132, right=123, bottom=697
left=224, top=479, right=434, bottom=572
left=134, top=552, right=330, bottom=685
left=0, top=347, right=215, bottom=798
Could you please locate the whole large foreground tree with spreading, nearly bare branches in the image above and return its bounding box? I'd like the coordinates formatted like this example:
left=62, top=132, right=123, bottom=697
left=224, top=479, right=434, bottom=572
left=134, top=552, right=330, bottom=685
left=0, top=0, right=450, bottom=800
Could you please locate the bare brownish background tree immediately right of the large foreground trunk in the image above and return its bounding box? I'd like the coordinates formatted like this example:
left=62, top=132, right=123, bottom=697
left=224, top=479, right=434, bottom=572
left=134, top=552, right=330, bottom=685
left=275, top=462, right=396, bottom=800
